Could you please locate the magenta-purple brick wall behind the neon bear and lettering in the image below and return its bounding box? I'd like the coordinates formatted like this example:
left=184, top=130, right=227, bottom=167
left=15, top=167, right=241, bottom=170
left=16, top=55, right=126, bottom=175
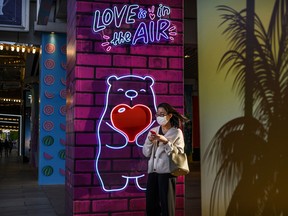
left=66, top=0, right=185, bottom=216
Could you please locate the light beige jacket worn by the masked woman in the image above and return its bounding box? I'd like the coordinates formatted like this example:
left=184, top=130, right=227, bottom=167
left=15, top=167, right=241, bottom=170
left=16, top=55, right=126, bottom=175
left=142, top=126, right=185, bottom=173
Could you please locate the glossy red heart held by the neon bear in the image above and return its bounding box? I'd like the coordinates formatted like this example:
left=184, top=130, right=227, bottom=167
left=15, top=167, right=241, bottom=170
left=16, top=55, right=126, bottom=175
left=110, top=104, right=152, bottom=142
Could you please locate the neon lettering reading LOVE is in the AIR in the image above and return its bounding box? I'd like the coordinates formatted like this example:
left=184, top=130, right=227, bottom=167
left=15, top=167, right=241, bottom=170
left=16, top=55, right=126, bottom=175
left=92, top=4, right=177, bottom=51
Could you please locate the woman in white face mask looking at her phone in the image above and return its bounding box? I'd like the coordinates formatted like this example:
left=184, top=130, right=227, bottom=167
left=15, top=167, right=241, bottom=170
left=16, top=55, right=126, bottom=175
left=143, top=103, right=188, bottom=216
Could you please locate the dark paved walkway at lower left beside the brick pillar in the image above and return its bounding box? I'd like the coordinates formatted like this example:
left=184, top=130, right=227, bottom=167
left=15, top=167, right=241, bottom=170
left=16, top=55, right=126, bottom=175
left=0, top=152, right=65, bottom=216
